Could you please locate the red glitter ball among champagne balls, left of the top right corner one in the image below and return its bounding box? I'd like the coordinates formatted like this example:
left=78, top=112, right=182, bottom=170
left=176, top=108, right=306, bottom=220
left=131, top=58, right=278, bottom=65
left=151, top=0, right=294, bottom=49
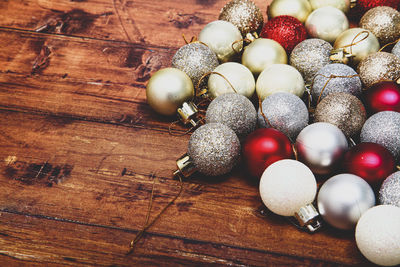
left=260, top=16, right=307, bottom=54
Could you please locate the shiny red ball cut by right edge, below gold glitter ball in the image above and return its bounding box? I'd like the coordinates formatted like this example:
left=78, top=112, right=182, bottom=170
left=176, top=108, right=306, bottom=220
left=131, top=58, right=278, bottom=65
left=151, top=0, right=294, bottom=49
left=365, top=81, right=400, bottom=114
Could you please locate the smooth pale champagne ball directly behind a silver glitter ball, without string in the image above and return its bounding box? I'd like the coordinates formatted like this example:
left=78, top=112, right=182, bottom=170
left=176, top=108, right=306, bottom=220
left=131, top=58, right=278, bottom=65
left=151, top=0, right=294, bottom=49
left=256, top=64, right=305, bottom=100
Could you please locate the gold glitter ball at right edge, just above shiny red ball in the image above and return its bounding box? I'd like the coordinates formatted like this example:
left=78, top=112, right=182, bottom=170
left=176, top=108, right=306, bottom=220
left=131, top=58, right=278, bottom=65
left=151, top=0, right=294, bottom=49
left=357, top=52, right=400, bottom=87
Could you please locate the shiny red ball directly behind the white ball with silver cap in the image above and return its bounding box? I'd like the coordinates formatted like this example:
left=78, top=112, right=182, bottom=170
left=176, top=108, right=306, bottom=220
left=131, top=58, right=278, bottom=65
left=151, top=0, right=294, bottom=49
left=243, top=128, right=294, bottom=178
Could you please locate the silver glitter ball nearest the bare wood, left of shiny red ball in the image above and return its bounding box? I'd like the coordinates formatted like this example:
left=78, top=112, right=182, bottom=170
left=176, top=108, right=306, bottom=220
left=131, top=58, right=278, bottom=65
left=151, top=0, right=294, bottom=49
left=188, top=123, right=240, bottom=176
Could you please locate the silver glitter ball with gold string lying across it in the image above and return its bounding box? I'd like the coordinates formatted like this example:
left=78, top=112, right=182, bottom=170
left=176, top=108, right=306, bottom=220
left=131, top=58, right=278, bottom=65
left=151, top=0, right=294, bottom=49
left=311, top=63, right=362, bottom=103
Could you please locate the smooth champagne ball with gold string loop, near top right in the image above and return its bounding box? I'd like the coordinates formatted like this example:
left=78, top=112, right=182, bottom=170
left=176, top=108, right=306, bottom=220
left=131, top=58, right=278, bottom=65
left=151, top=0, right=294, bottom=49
left=333, top=28, right=380, bottom=65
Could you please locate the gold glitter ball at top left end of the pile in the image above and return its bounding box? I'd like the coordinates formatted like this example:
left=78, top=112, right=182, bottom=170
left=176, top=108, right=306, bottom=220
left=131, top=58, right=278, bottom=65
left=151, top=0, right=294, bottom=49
left=218, top=0, right=264, bottom=37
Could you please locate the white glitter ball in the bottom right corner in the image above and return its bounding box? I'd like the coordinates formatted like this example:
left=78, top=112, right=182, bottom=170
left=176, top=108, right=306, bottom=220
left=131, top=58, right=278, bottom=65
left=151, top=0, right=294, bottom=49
left=355, top=205, right=400, bottom=266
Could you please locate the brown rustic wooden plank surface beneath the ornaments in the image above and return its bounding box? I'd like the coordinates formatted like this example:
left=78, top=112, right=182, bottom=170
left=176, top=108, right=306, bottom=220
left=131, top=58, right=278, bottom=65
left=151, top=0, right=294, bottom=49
left=0, top=0, right=376, bottom=266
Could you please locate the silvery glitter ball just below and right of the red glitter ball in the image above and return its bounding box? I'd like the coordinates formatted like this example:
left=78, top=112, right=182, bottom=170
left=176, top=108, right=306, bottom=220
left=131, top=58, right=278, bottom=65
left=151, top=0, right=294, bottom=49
left=290, top=38, right=332, bottom=84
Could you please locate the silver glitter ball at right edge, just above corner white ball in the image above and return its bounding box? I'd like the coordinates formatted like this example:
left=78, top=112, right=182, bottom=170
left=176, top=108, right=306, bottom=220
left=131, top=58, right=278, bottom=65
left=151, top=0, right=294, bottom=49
left=379, top=171, right=400, bottom=208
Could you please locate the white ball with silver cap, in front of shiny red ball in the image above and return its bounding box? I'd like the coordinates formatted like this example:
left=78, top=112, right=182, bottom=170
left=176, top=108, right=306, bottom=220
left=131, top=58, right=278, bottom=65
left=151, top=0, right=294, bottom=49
left=260, top=159, right=317, bottom=216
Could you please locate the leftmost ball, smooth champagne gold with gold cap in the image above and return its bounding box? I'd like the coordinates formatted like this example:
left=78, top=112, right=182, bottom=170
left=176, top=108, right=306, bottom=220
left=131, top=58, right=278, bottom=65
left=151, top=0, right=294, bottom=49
left=146, top=68, right=194, bottom=116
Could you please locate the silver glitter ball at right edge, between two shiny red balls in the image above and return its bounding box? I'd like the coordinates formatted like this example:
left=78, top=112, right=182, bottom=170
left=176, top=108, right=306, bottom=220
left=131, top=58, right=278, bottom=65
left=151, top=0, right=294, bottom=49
left=360, top=111, right=400, bottom=161
